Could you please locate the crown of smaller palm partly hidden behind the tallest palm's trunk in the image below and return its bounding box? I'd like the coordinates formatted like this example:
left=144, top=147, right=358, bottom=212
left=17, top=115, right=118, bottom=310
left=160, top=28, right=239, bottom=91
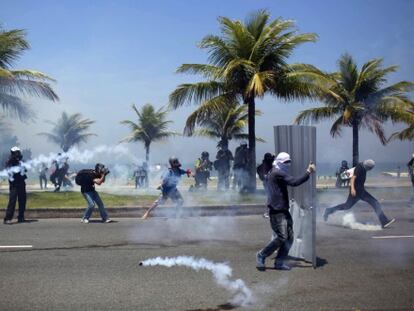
left=184, top=103, right=263, bottom=147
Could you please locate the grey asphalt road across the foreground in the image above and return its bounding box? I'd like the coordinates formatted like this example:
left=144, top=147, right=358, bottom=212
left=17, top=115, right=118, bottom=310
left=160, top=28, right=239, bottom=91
left=0, top=207, right=414, bottom=310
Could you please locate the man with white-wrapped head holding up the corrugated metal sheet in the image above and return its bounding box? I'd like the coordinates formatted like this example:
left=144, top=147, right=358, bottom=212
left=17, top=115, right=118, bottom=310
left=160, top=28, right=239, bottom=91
left=256, top=152, right=316, bottom=271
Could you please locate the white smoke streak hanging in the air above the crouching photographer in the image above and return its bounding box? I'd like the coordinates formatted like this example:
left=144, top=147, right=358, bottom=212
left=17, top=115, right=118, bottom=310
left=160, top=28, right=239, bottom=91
left=0, top=145, right=138, bottom=181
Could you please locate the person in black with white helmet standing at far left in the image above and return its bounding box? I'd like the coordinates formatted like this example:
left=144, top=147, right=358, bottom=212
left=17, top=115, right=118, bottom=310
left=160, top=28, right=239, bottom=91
left=3, top=147, right=27, bottom=224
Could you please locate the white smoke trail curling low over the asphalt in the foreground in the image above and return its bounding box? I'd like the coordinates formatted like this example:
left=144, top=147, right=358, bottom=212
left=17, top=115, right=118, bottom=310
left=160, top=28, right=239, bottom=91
left=139, top=256, right=253, bottom=306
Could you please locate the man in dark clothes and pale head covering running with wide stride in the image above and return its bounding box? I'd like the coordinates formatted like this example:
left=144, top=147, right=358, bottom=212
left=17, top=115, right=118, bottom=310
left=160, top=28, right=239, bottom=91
left=323, top=159, right=395, bottom=228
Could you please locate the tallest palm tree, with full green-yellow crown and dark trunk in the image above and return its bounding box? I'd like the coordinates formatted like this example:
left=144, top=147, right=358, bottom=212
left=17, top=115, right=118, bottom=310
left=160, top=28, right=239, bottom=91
left=170, top=10, right=316, bottom=190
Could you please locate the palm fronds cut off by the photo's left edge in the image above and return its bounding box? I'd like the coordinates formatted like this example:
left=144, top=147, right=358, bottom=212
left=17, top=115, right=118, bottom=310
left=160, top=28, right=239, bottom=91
left=0, top=27, right=59, bottom=119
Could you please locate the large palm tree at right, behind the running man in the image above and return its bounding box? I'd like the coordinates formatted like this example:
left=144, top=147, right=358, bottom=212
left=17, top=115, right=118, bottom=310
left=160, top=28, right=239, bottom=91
left=295, top=54, right=414, bottom=166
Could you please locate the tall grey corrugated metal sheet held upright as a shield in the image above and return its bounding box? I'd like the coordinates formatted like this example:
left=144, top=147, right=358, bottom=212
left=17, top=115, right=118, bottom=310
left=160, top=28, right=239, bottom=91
left=274, top=125, right=316, bottom=267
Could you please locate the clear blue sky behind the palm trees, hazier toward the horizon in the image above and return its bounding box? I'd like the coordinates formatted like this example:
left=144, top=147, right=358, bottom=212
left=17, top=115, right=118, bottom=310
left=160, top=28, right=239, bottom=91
left=0, top=0, right=414, bottom=163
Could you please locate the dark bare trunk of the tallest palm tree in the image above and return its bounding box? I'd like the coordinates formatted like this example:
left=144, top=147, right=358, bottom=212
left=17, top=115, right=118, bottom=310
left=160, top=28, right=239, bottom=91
left=247, top=98, right=256, bottom=191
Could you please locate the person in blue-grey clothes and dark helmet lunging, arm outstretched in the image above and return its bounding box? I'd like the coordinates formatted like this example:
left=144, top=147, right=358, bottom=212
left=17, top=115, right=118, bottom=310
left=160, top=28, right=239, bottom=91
left=142, top=157, right=191, bottom=219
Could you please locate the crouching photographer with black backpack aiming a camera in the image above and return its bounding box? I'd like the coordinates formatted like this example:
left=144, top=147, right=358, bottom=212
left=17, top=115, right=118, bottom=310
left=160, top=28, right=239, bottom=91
left=75, top=163, right=112, bottom=224
